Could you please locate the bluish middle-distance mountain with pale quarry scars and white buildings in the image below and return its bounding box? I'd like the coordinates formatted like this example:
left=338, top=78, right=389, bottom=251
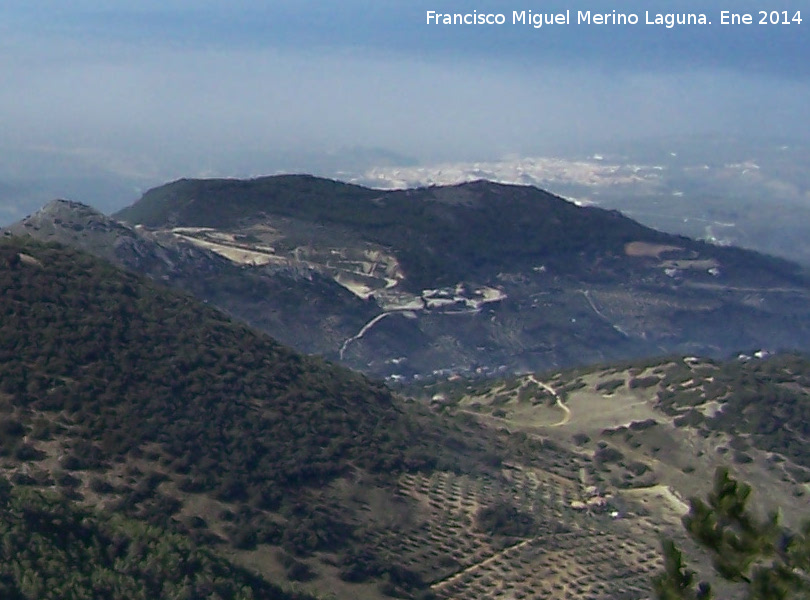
left=10, top=175, right=810, bottom=380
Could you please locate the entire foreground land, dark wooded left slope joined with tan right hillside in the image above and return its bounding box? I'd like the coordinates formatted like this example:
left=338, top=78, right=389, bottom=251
left=6, top=236, right=810, bottom=600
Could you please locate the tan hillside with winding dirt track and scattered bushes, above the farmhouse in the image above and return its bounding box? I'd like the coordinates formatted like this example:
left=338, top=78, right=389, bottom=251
left=408, top=353, right=810, bottom=525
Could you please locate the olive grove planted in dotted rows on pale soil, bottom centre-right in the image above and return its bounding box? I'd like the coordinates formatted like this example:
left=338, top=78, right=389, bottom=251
left=390, top=470, right=660, bottom=599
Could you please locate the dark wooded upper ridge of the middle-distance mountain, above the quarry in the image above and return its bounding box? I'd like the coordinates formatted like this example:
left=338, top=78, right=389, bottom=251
left=115, top=175, right=793, bottom=292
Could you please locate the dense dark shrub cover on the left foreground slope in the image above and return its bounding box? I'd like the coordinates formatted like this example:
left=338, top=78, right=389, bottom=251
left=0, top=240, right=454, bottom=490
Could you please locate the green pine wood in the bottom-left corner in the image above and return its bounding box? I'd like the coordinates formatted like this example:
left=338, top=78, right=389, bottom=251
left=0, top=480, right=310, bottom=600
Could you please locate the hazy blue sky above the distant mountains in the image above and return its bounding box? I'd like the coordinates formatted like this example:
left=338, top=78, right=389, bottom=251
left=0, top=0, right=810, bottom=216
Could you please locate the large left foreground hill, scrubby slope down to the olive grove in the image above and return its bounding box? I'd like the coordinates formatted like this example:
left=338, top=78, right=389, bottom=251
left=0, top=238, right=724, bottom=599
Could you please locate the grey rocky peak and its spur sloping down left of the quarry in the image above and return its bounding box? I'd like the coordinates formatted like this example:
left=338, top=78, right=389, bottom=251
left=5, top=200, right=375, bottom=354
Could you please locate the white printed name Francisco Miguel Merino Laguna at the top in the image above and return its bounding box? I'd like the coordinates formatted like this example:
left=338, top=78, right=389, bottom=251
left=427, top=9, right=710, bottom=29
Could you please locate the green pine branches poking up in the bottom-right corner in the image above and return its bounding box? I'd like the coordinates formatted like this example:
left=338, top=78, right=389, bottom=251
left=653, top=468, right=810, bottom=600
